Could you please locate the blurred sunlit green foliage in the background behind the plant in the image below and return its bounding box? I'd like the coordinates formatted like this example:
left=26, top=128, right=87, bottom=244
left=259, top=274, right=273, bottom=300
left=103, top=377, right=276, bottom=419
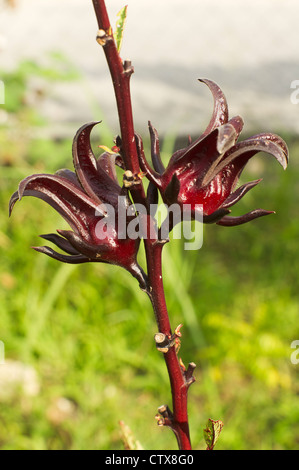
left=0, top=63, right=299, bottom=450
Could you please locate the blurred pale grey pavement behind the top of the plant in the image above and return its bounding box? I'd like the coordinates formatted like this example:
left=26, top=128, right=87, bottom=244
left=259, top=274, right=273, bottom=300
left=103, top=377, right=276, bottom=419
left=0, top=0, right=299, bottom=140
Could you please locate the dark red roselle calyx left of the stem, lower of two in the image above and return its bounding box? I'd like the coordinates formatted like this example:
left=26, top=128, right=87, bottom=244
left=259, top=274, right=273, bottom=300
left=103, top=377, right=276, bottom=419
left=9, top=122, right=146, bottom=288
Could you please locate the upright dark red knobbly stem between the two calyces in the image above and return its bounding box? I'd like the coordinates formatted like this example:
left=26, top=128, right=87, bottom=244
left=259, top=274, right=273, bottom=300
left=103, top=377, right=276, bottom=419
left=93, top=0, right=194, bottom=450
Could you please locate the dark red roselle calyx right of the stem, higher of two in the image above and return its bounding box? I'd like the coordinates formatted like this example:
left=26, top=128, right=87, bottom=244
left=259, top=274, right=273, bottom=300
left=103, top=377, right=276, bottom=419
left=137, top=79, right=288, bottom=226
